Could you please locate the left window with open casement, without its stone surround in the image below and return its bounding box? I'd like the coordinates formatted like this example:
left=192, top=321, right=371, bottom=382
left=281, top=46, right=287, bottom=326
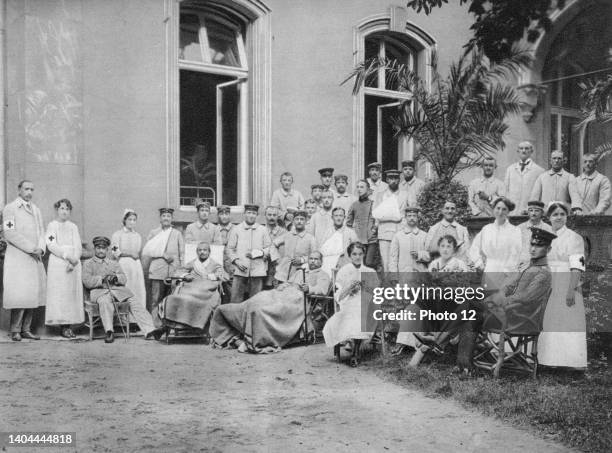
left=178, top=4, right=249, bottom=206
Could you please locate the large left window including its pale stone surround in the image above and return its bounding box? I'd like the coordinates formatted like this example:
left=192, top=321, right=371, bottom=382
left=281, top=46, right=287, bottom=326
left=167, top=0, right=271, bottom=209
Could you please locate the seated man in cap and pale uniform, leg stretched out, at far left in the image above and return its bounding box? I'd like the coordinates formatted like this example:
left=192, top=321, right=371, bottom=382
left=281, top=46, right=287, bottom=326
left=83, top=236, right=162, bottom=343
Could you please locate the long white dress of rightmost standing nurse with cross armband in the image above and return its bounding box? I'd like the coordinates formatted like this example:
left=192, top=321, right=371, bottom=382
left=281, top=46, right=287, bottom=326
left=538, top=226, right=587, bottom=368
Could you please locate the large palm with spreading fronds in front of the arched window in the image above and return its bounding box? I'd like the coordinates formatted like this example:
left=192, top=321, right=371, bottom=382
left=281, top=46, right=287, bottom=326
left=343, top=49, right=532, bottom=183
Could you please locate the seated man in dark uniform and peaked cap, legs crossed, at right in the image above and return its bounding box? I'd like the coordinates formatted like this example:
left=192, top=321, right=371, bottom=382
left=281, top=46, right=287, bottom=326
left=410, top=228, right=557, bottom=369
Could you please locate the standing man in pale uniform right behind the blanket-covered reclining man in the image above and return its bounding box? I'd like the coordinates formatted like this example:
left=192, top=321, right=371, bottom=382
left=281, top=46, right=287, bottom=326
left=275, top=211, right=317, bottom=282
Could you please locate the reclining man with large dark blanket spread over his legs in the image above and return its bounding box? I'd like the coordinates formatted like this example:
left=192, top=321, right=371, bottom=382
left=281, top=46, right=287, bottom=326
left=210, top=252, right=330, bottom=353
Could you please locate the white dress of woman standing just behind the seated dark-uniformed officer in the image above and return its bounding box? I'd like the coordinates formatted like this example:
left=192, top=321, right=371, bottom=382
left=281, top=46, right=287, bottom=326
left=468, top=220, right=522, bottom=289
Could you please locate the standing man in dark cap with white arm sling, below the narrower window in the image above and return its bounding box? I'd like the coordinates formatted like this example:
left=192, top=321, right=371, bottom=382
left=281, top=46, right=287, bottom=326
left=372, top=170, right=407, bottom=272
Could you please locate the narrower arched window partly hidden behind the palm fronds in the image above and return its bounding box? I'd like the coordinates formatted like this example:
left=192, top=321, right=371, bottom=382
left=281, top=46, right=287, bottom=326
left=363, top=32, right=418, bottom=169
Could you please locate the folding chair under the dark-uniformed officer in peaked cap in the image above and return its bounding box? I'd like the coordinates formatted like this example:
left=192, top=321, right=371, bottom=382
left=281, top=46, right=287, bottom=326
left=474, top=289, right=552, bottom=379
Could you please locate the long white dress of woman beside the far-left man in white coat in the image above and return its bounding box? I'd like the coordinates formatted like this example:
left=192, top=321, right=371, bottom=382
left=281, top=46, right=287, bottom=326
left=45, top=220, right=85, bottom=325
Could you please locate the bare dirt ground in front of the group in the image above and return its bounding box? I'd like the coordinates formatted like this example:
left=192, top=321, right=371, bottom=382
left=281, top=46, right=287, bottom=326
left=0, top=333, right=566, bottom=453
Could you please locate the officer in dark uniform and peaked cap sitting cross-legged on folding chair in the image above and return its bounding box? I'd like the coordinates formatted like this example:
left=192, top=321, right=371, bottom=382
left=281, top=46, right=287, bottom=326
left=414, top=227, right=557, bottom=373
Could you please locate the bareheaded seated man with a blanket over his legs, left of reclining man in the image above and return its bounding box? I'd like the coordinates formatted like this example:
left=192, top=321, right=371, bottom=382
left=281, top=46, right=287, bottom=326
left=159, top=242, right=229, bottom=333
